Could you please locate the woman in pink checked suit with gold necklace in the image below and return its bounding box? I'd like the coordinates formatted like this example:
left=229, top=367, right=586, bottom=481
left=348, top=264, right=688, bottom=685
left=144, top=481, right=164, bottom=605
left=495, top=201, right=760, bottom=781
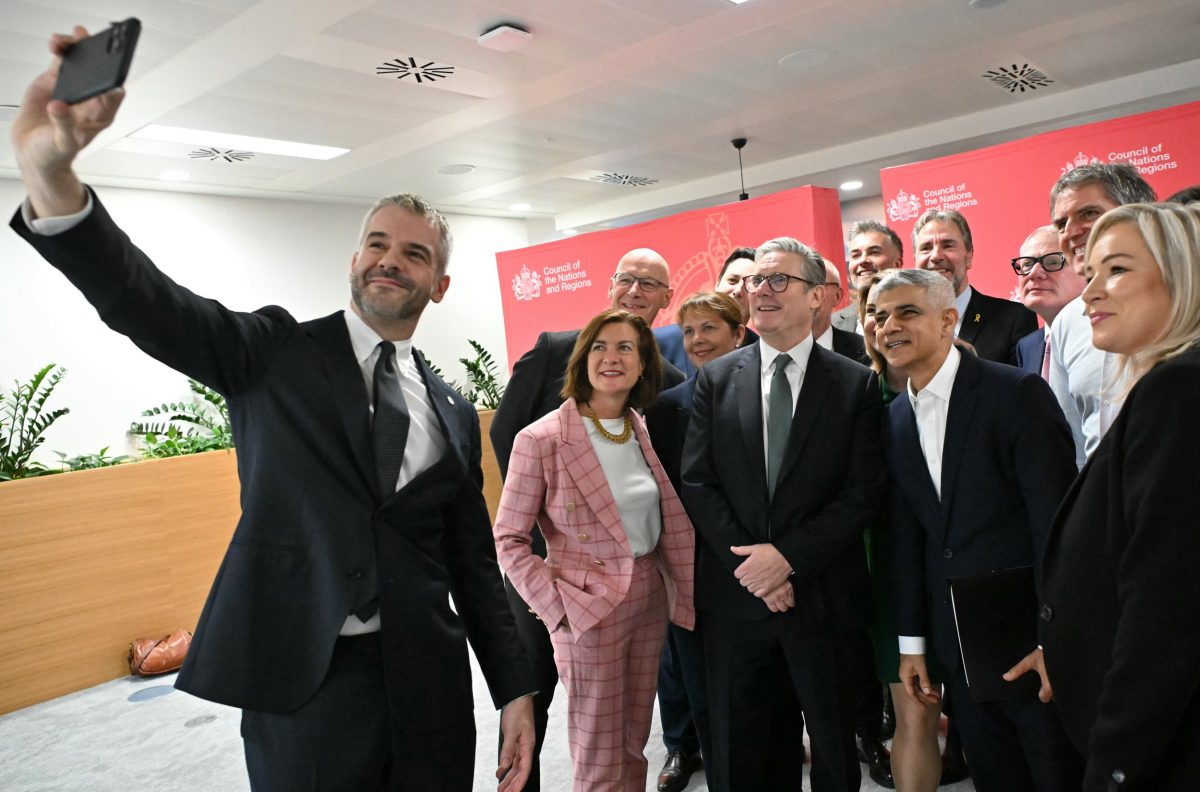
left=494, top=311, right=696, bottom=792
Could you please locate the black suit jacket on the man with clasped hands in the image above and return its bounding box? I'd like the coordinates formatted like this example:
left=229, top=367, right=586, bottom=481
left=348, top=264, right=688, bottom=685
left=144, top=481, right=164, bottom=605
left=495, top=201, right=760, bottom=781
left=682, top=343, right=886, bottom=634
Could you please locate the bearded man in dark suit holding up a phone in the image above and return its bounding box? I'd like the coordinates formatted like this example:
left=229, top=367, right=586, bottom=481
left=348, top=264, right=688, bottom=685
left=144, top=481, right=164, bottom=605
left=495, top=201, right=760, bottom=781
left=12, top=28, right=533, bottom=792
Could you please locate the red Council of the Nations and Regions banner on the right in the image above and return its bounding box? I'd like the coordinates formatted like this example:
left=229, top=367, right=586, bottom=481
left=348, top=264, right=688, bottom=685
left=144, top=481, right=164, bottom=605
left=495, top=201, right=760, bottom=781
left=880, top=102, right=1200, bottom=296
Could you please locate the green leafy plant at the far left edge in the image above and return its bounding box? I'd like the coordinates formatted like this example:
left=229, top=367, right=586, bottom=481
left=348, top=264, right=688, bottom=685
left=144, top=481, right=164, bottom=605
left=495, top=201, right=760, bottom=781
left=0, top=364, right=71, bottom=481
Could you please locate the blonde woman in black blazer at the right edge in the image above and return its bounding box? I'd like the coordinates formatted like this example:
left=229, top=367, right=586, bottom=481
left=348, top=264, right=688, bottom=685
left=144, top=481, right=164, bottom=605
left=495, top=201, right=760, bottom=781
left=1039, top=204, right=1200, bottom=792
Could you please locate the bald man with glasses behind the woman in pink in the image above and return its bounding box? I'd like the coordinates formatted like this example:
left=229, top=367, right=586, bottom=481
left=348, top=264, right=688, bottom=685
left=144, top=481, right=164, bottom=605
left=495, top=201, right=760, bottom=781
left=488, top=247, right=684, bottom=792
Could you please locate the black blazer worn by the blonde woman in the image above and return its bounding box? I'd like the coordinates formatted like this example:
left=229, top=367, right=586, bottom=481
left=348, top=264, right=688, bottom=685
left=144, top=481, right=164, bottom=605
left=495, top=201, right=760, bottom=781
left=1040, top=347, right=1200, bottom=792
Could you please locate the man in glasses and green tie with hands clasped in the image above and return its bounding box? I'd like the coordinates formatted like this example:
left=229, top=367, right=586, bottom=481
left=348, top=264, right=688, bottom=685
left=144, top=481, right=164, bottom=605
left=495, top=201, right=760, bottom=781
left=680, top=238, right=884, bottom=792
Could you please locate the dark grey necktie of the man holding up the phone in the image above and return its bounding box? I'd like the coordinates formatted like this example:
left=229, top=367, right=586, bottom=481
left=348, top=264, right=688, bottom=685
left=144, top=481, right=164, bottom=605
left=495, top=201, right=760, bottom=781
left=353, top=341, right=409, bottom=622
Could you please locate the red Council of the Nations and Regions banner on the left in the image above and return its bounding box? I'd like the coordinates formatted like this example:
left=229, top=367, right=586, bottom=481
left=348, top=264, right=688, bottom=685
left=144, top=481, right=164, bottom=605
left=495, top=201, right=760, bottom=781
left=496, top=187, right=845, bottom=370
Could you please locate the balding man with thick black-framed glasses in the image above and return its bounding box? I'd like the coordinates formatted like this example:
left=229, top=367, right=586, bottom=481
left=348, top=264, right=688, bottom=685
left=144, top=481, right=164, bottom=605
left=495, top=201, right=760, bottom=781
left=1013, top=226, right=1087, bottom=382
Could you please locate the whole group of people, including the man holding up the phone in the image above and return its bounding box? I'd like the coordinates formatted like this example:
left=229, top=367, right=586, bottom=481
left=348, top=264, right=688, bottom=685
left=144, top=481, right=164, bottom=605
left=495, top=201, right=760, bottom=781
left=11, top=23, right=1200, bottom=792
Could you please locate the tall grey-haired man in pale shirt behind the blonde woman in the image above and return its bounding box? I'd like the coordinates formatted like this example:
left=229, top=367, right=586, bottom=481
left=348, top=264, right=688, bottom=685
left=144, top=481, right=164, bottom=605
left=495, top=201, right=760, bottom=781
left=1046, top=162, right=1156, bottom=469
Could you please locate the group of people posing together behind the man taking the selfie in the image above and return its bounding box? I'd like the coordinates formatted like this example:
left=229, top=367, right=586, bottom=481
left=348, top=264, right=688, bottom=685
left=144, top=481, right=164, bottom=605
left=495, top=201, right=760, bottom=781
left=492, top=164, right=1200, bottom=792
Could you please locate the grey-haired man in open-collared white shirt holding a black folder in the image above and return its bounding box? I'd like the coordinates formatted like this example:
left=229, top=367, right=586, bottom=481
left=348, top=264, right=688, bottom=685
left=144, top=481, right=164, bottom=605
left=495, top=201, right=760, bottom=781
left=872, top=270, right=1084, bottom=792
